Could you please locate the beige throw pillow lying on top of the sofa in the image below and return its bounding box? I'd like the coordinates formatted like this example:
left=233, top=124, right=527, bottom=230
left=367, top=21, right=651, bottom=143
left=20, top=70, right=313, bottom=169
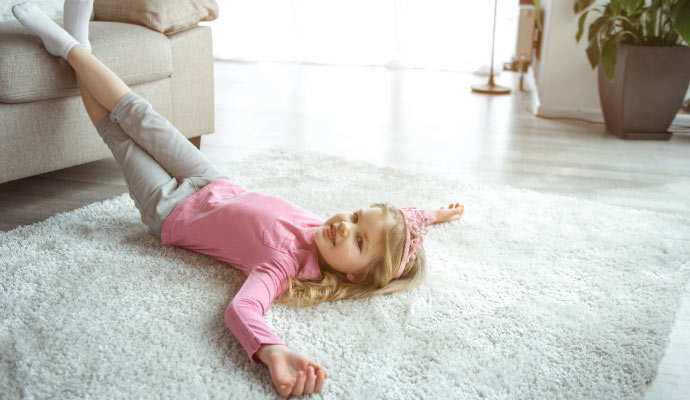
left=93, top=0, right=218, bottom=35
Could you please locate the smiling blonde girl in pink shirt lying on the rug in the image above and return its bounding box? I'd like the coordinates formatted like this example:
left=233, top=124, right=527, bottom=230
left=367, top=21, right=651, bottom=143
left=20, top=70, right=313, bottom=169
left=12, top=0, right=464, bottom=396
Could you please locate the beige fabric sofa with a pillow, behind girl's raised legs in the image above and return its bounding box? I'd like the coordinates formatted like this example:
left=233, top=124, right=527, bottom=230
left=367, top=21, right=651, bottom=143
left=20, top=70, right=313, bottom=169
left=0, top=0, right=218, bottom=183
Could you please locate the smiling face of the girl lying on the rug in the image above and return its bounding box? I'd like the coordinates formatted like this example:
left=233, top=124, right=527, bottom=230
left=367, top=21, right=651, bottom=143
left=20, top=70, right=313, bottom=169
left=315, top=207, right=388, bottom=282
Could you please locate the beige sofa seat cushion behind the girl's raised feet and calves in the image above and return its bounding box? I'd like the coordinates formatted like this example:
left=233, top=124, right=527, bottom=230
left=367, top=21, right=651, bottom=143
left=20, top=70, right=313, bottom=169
left=0, top=21, right=172, bottom=103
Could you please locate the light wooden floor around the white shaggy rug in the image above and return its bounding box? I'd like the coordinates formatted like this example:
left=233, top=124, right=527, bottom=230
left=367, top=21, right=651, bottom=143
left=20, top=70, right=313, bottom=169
left=0, top=62, right=690, bottom=399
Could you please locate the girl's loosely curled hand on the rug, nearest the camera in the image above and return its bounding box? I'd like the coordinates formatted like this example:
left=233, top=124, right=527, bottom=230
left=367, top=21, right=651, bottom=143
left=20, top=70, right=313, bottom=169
left=258, top=345, right=328, bottom=397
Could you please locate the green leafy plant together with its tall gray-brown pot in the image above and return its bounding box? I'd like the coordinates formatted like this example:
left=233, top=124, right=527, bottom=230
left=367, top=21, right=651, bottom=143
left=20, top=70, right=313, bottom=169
left=574, top=0, right=690, bottom=140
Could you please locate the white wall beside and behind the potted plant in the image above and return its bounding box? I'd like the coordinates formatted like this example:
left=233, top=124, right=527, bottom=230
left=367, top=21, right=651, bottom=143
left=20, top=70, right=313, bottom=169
left=528, top=0, right=690, bottom=125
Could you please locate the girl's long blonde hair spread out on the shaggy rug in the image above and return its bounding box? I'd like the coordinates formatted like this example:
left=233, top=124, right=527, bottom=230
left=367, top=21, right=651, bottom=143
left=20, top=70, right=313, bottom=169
left=276, top=203, right=426, bottom=307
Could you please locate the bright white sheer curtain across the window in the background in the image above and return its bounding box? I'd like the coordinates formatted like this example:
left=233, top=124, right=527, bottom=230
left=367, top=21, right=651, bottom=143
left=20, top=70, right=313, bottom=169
left=206, top=0, right=519, bottom=72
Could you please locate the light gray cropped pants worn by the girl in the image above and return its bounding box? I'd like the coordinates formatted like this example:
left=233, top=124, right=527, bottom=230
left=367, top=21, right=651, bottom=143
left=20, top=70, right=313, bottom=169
left=96, top=92, right=227, bottom=237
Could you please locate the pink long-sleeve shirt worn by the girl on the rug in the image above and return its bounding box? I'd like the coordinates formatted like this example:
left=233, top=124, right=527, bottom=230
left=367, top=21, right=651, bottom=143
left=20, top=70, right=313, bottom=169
left=161, top=179, right=323, bottom=364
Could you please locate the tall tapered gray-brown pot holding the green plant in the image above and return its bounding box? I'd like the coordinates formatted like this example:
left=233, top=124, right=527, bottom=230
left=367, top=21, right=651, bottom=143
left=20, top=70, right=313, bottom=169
left=599, top=45, right=690, bottom=140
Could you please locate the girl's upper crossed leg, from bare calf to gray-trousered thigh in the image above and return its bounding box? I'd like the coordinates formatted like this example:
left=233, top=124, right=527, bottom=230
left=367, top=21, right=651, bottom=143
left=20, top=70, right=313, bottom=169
left=67, top=46, right=222, bottom=186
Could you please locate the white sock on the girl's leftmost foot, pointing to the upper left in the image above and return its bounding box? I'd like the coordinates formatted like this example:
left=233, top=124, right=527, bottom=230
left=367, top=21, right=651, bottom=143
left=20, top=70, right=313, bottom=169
left=12, top=3, right=79, bottom=59
